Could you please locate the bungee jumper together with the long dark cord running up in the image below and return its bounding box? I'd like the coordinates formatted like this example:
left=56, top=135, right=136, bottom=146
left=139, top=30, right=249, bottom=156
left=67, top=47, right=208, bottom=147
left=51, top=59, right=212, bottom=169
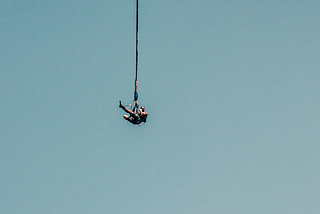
left=119, top=0, right=148, bottom=125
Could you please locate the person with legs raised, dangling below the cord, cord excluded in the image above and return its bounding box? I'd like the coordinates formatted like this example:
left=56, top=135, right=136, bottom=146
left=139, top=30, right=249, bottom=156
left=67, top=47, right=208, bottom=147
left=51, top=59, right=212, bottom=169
left=119, top=100, right=148, bottom=125
